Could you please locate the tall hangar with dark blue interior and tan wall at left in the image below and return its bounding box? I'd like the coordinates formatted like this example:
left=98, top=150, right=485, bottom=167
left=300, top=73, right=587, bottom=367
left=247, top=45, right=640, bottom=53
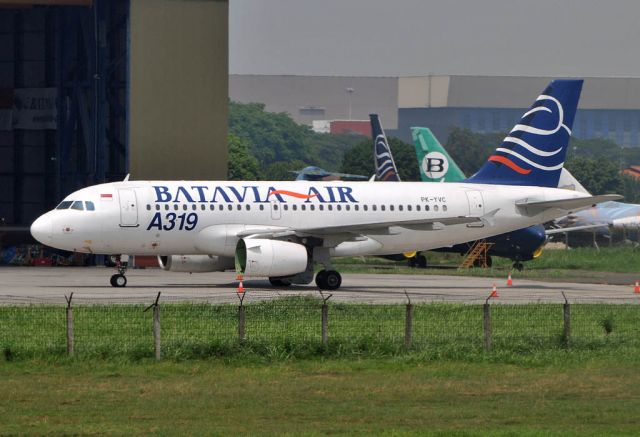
left=0, top=0, right=228, bottom=234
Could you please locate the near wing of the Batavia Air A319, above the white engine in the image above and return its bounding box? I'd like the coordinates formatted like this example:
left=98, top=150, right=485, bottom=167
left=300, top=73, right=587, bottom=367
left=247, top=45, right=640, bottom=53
left=236, top=216, right=482, bottom=238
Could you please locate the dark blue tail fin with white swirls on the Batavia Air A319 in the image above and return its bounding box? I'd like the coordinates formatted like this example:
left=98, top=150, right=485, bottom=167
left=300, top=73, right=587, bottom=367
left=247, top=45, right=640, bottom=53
left=465, top=79, right=583, bottom=187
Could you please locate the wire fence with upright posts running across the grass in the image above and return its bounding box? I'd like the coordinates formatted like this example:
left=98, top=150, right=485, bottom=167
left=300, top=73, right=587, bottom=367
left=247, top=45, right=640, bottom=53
left=0, top=294, right=640, bottom=360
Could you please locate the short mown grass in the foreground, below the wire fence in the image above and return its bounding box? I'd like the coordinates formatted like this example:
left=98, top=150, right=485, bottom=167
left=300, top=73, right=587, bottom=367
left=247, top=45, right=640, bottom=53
left=0, top=357, right=640, bottom=436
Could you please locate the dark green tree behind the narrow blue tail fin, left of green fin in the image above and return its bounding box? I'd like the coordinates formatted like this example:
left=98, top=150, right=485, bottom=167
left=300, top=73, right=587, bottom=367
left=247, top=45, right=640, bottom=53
left=340, top=137, right=420, bottom=181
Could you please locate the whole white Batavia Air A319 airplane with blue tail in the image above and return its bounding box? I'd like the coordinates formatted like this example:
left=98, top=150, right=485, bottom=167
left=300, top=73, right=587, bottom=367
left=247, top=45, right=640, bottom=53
left=31, top=80, right=621, bottom=290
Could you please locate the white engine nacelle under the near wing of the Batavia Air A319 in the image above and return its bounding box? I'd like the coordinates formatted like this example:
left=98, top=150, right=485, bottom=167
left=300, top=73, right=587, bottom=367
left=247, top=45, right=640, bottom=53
left=236, top=238, right=309, bottom=277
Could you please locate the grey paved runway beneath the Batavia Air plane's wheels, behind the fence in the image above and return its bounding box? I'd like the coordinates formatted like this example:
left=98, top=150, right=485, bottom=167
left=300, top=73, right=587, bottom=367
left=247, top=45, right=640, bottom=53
left=0, top=267, right=640, bottom=305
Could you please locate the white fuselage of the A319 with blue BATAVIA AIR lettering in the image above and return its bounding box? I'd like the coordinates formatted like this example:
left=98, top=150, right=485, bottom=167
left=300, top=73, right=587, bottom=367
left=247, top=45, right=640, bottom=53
left=32, top=181, right=586, bottom=256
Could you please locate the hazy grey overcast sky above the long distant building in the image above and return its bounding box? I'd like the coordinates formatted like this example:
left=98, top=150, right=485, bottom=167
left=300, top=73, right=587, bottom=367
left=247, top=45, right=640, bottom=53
left=229, top=0, right=640, bottom=77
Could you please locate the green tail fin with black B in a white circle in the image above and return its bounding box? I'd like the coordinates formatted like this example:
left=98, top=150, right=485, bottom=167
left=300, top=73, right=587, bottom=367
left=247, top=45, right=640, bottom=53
left=411, top=127, right=465, bottom=182
